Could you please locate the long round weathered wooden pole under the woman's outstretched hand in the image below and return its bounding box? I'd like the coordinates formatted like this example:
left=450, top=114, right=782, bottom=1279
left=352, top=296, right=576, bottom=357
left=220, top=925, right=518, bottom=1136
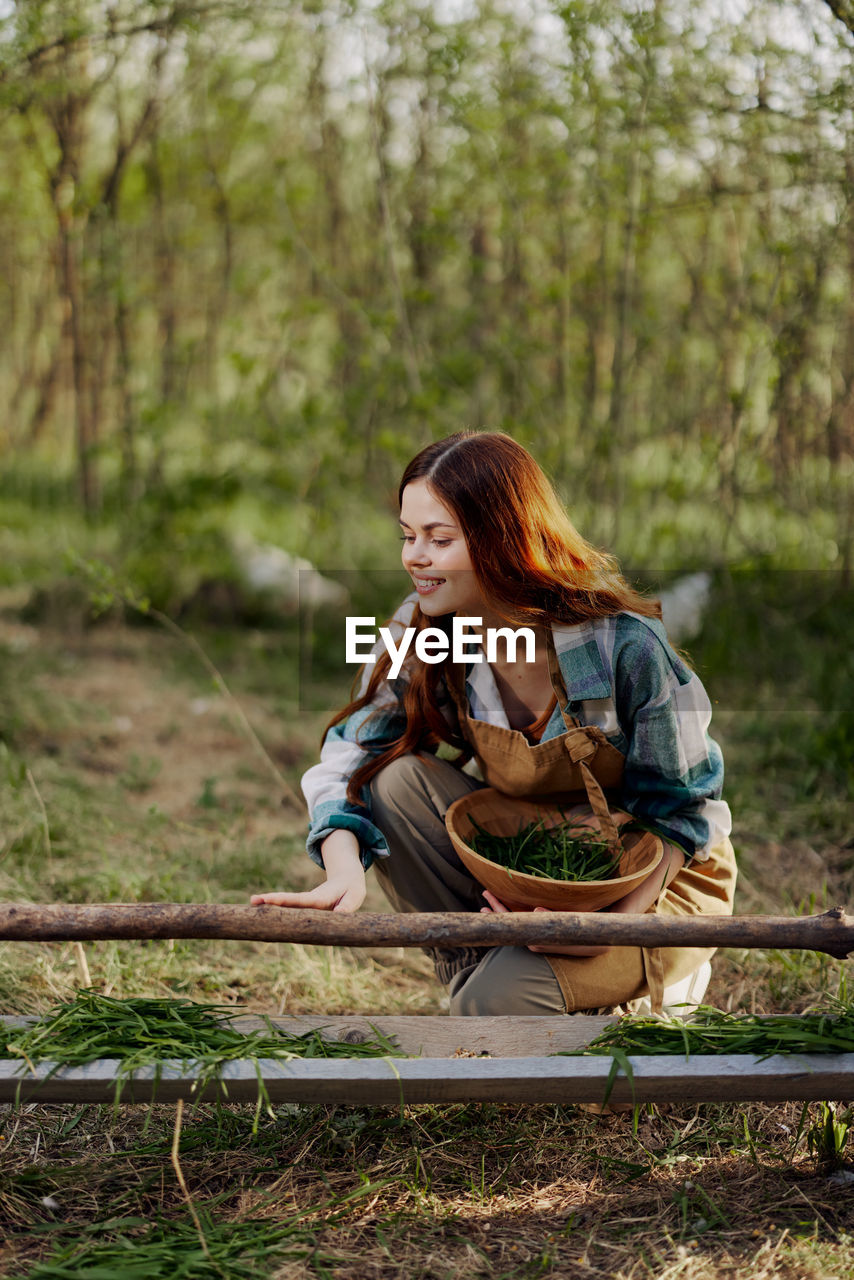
left=0, top=902, right=854, bottom=959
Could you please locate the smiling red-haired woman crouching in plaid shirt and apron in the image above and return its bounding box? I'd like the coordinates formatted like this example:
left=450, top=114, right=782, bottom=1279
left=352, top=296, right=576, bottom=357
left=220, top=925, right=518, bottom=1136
left=252, top=431, right=735, bottom=1014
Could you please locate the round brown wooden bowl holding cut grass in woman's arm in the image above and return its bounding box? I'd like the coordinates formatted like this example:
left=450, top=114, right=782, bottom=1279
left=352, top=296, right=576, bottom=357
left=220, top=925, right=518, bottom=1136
left=444, top=787, right=665, bottom=911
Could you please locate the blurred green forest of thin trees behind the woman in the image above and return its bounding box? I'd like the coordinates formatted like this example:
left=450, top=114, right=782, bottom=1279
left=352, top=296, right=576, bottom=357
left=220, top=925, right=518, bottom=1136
left=0, top=0, right=854, bottom=593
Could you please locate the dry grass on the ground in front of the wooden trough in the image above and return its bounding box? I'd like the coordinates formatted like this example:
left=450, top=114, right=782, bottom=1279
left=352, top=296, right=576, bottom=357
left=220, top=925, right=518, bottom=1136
left=0, top=1105, right=854, bottom=1280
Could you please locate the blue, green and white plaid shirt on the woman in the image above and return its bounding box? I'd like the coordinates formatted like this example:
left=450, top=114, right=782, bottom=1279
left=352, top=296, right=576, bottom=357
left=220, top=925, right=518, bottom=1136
left=302, top=595, right=732, bottom=867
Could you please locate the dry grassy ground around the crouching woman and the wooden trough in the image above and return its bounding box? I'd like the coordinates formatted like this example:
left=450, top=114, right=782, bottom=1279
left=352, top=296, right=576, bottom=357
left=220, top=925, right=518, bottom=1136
left=0, top=616, right=854, bottom=1280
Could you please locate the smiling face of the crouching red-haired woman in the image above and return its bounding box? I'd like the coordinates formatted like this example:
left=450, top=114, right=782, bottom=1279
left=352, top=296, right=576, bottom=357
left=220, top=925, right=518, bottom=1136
left=401, top=480, right=487, bottom=617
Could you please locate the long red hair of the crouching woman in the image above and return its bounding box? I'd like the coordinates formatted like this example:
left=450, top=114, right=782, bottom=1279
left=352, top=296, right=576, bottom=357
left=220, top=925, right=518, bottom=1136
left=324, top=431, right=661, bottom=804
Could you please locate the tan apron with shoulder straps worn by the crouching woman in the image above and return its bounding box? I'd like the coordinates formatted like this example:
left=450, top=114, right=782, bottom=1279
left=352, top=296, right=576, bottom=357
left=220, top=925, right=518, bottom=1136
left=448, top=635, right=736, bottom=1010
